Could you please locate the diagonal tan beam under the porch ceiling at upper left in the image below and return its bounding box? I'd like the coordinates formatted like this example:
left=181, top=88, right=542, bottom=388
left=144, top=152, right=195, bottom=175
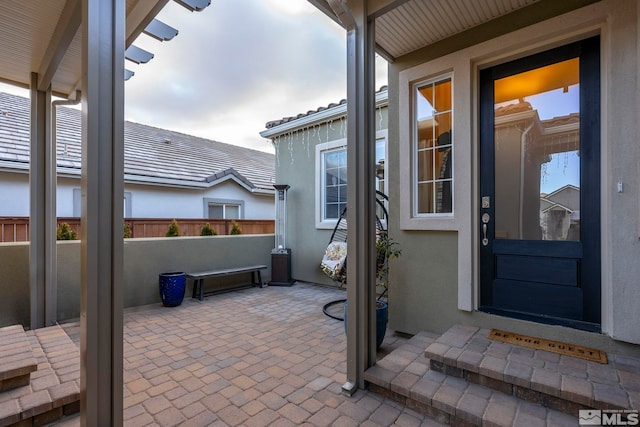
left=38, top=0, right=82, bottom=91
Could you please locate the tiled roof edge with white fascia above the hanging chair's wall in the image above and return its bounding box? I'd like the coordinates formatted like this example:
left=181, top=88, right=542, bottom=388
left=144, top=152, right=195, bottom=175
left=260, top=86, right=389, bottom=138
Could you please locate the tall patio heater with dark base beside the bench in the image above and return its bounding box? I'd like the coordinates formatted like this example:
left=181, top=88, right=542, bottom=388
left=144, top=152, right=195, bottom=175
left=269, top=184, right=293, bottom=286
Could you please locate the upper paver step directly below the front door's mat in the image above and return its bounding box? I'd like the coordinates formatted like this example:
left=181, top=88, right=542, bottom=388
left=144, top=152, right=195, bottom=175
left=425, top=326, right=640, bottom=414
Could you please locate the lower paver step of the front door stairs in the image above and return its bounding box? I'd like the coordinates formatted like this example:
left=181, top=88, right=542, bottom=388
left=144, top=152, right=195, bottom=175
left=365, top=332, right=578, bottom=427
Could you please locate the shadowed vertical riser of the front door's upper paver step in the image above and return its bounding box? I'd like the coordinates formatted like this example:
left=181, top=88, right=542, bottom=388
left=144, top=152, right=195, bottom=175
left=430, top=360, right=592, bottom=415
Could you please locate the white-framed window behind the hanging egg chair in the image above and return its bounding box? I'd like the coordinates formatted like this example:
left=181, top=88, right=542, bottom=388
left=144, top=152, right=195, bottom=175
left=316, top=130, right=388, bottom=229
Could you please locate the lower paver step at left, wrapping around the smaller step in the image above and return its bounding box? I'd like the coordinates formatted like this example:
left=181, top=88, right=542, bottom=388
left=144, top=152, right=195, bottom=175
left=0, top=325, right=80, bottom=427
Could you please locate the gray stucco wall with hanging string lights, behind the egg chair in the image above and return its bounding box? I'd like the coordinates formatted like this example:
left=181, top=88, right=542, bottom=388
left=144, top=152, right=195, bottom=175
left=274, top=107, right=387, bottom=285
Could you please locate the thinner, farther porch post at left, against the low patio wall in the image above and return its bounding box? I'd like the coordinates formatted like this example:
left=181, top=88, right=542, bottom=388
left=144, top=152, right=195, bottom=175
left=29, top=73, right=58, bottom=329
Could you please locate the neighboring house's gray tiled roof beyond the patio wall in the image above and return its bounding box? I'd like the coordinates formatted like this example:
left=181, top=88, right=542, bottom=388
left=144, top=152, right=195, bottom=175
left=0, top=93, right=275, bottom=194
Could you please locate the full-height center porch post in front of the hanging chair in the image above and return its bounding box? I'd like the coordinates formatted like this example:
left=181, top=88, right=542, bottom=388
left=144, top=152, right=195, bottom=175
left=341, top=0, right=376, bottom=394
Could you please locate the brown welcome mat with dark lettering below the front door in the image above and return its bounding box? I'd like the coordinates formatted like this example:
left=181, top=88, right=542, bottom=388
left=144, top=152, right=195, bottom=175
left=488, top=329, right=607, bottom=364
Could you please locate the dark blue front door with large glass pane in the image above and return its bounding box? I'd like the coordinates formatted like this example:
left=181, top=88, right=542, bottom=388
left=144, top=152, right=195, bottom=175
left=479, top=37, right=600, bottom=330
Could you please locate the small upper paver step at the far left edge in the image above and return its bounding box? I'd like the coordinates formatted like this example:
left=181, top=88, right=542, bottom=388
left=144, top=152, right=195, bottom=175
left=0, top=325, right=38, bottom=392
